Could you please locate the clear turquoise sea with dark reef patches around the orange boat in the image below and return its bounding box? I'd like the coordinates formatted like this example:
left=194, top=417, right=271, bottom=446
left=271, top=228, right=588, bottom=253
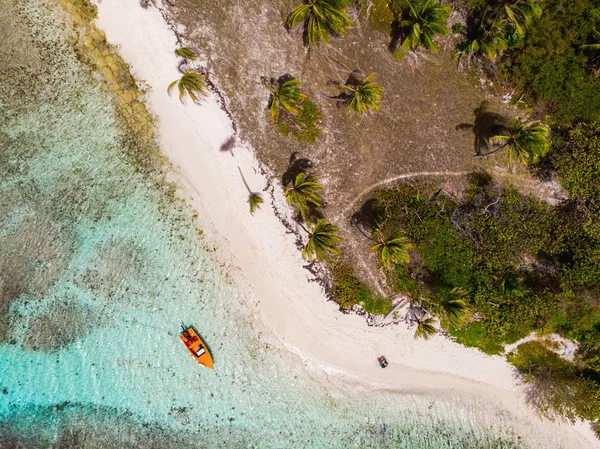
left=0, top=0, right=568, bottom=449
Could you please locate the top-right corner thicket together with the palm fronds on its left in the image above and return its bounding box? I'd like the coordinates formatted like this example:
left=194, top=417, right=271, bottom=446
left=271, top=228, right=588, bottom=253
left=459, top=0, right=600, bottom=124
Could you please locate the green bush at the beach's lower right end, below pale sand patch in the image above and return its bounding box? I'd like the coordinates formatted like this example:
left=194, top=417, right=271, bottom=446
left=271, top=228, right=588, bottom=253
left=508, top=341, right=600, bottom=421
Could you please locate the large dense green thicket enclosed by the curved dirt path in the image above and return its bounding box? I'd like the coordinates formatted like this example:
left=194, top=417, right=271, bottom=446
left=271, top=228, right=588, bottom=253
left=375, top=173, right=600, bottom=350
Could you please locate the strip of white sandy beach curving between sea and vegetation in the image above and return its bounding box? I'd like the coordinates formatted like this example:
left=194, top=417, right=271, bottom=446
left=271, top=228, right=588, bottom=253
left=97, top=0, right=600, bottom=448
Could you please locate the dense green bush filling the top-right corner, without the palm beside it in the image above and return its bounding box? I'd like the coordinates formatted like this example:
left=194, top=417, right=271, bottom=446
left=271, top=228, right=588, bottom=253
left=461, top=0, right=600, bottom=124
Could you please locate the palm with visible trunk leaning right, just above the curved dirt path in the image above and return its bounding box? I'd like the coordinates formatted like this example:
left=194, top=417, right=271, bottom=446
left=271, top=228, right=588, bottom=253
left=476, top=119, right=550, bottom=170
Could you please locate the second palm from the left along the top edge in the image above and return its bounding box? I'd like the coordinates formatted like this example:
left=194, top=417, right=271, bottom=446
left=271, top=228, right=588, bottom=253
left=400, top=0, right=451, bottom=52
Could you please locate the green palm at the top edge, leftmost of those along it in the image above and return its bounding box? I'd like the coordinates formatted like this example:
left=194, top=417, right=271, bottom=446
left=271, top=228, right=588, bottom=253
left=286, top=0, right=352, bottom=48
